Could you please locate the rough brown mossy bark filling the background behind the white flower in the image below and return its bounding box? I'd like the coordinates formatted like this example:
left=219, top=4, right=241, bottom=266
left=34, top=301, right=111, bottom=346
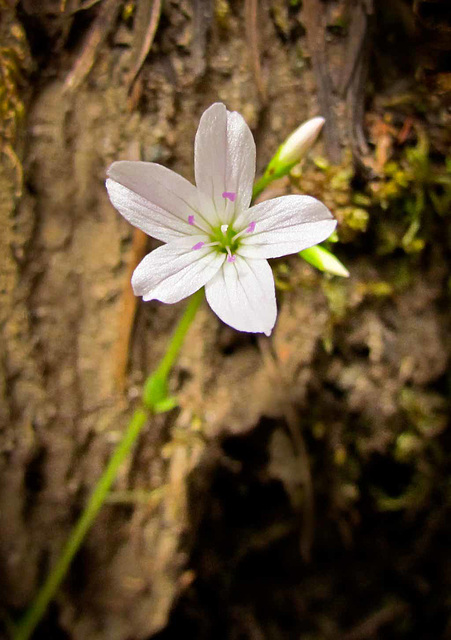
left=0, top=0, right=451, bottom=640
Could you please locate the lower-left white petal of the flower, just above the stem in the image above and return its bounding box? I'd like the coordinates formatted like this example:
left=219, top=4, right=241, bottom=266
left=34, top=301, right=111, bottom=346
left=132, top=235, right=225, bottom=304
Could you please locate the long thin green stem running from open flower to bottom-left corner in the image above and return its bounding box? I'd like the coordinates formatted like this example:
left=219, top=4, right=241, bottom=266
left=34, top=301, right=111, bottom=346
left=12, top=289, right=203, bottom=640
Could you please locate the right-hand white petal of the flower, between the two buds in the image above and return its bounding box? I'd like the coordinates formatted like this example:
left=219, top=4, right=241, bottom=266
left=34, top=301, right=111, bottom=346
left=235, top=196, right=337, bottom=259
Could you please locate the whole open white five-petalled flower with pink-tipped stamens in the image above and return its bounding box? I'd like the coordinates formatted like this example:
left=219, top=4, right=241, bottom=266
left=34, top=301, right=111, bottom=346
left=106, top=103, right=336, bottom=335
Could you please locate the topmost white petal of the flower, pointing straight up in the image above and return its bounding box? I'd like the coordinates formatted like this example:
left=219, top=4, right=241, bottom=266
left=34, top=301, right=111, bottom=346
left=194, top=102, right=255, bottom=225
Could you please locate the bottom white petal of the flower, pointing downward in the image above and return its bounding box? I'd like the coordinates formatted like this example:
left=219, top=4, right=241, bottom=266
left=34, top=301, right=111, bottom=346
left=205, top=256, right=277, bottom=336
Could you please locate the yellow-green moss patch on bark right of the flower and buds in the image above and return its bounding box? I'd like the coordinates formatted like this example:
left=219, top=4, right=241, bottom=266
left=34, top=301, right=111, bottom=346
left=298, top=114, right=451, bottom=264
